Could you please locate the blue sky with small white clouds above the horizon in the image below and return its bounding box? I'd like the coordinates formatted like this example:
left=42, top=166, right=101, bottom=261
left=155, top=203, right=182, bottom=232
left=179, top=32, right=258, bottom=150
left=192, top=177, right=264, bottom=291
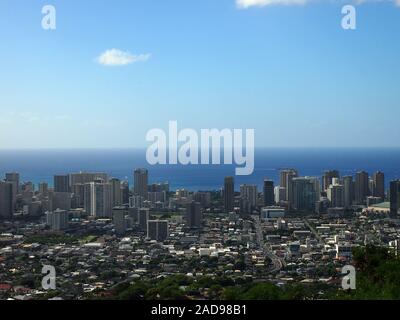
left=0, top=0, right=400, bottom=149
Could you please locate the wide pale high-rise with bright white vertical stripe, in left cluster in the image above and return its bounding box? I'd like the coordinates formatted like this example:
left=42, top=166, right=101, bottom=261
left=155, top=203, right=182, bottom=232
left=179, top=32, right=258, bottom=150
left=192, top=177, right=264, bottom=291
left=85, top=180, right=112, bottom=218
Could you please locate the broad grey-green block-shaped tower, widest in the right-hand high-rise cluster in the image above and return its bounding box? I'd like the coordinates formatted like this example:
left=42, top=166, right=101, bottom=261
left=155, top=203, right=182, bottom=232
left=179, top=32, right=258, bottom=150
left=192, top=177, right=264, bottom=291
left=293, top=177, right=320, bottom=212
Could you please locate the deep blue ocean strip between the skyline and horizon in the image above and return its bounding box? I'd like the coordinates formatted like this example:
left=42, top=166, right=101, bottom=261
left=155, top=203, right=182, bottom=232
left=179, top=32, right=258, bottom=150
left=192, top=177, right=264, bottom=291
left=0, top=148, right=400, bottom=191
